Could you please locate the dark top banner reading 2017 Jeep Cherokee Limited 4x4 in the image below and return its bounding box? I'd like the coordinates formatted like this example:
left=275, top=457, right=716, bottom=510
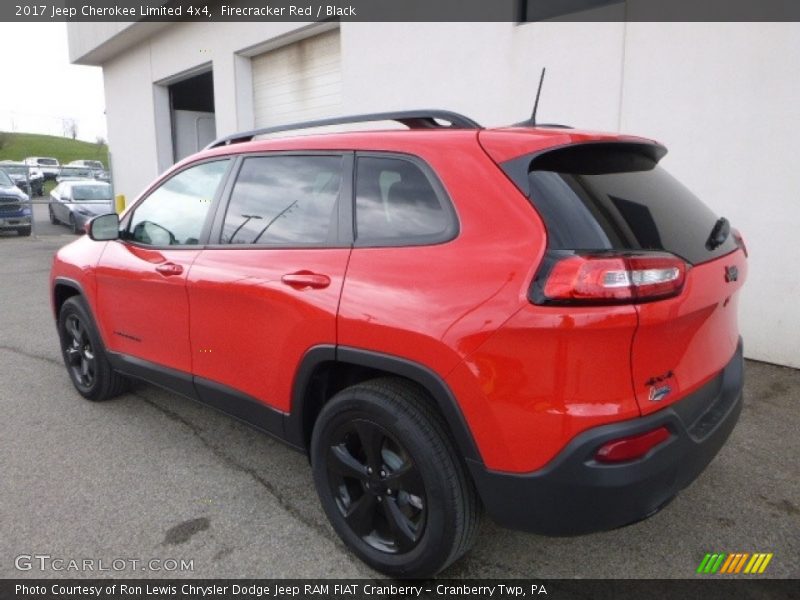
left=0, top=0, right=800, bottom=23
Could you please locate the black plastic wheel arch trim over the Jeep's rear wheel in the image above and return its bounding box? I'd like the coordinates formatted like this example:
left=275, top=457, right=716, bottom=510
left=285, top=345, right=483, bottom=464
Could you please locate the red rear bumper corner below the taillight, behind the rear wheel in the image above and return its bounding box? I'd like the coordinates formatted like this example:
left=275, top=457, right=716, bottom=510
left=454, top=304, right=640, bottom=473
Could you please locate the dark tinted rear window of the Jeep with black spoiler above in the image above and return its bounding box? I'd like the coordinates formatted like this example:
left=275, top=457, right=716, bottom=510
left=527, top=143, right=736, bottom=264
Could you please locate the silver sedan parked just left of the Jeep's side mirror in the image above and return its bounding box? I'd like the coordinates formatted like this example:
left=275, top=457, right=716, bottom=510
left=49, top=180, right=112, bottom=233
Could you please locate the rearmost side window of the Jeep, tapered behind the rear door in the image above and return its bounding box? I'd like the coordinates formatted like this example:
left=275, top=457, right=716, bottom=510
left=356, top=156, right=455, bottom=243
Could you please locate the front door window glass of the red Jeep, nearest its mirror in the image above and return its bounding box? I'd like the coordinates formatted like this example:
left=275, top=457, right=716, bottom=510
left=128, top=159, right=230, bottom=246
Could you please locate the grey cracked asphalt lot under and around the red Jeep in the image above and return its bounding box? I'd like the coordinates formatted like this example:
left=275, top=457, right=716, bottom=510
left=0, top=223, right=800, bottom=578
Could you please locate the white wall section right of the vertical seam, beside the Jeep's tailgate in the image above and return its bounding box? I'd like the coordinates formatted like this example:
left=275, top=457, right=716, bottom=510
left=621, top=23, right=800, bottom=367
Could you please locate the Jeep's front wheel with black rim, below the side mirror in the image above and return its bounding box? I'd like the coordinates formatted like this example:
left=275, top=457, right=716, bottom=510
left=58, top=296, right=128, bottom=402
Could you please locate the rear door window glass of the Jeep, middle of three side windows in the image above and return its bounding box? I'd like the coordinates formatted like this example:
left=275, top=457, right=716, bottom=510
left=221, top=156, right=342, bottom=246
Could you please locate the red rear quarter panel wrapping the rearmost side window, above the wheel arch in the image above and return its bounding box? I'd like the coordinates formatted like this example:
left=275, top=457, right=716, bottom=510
left=338, top=138, right=545, bottom=376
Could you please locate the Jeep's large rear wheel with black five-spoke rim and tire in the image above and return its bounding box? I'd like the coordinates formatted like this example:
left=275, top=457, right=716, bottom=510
left=311, top=378, right=479, bottom=577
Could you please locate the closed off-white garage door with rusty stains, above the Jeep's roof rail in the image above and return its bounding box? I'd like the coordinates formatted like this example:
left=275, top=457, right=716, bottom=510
left=252, top=29, right=342, bottom=127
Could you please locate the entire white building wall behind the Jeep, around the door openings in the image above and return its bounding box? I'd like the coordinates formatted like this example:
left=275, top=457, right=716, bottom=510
left=70, top=21, right=800, bottom=367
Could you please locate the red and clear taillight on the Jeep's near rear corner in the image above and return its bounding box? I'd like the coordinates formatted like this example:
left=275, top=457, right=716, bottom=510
left=542, top=253, right=687, bottom=304
